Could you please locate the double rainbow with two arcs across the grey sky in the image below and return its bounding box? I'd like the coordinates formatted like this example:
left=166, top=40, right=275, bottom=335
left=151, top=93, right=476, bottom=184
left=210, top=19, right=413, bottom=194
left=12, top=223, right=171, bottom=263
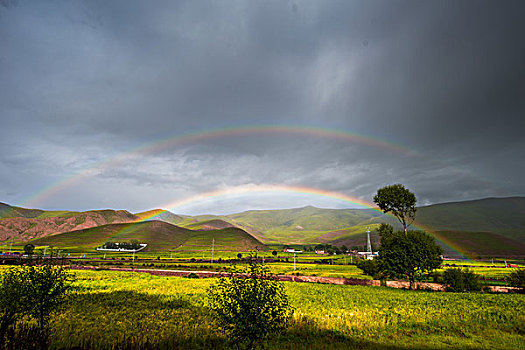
left=16, top=125, right=466, bottom=256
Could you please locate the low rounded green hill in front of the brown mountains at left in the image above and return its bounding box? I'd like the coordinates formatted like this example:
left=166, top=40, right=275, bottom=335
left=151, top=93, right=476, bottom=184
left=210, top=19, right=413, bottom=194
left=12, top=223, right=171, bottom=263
left=31, top=221, right=264, bottom=252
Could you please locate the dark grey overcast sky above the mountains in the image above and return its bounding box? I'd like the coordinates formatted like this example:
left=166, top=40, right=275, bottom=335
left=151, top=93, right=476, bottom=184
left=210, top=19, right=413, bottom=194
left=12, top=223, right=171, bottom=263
left=0, top=0, right=525, bottom=214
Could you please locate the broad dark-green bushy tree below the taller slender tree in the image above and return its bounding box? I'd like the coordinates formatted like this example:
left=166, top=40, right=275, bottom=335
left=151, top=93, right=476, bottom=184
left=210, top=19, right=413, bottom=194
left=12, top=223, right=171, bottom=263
left=377, top=230, right=443, bottom=289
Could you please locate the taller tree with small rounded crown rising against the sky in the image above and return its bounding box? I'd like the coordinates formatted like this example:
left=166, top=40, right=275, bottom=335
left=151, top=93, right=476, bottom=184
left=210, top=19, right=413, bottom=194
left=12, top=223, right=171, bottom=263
left=374, top=184, right=417, bottom=233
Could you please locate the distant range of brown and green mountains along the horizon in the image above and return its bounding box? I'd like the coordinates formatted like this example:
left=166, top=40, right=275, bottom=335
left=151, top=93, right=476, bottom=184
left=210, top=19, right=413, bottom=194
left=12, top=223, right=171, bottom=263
left=0, top=197, right=525, bottom=256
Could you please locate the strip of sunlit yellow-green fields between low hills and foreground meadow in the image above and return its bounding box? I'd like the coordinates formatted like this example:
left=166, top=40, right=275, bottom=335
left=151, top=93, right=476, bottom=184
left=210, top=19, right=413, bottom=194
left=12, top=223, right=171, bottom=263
left=0, top=245, right=525, bottom=285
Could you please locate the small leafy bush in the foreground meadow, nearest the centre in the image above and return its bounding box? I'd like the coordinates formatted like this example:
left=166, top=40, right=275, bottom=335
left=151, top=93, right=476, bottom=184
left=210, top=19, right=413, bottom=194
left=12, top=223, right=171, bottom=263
left=208, top=257, right=293, bottom=349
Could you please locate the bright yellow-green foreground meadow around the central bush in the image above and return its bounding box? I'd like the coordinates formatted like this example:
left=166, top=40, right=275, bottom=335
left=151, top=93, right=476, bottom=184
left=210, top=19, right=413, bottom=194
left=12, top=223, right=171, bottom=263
left=18, top=271, right=525, bottom=349
